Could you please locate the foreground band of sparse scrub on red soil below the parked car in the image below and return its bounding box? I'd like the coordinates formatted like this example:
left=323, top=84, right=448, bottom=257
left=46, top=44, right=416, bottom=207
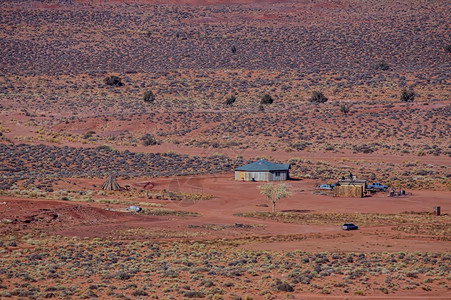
left=0, top=236, right=450, bottom=299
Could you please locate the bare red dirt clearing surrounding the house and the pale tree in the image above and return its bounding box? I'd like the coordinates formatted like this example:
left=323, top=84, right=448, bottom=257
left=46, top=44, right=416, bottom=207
left=0, top=174, right=450, bottom=252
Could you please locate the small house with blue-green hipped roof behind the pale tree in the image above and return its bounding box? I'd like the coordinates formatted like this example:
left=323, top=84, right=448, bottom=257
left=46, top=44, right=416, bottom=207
left=235, top=159, right=290, bottom=181
